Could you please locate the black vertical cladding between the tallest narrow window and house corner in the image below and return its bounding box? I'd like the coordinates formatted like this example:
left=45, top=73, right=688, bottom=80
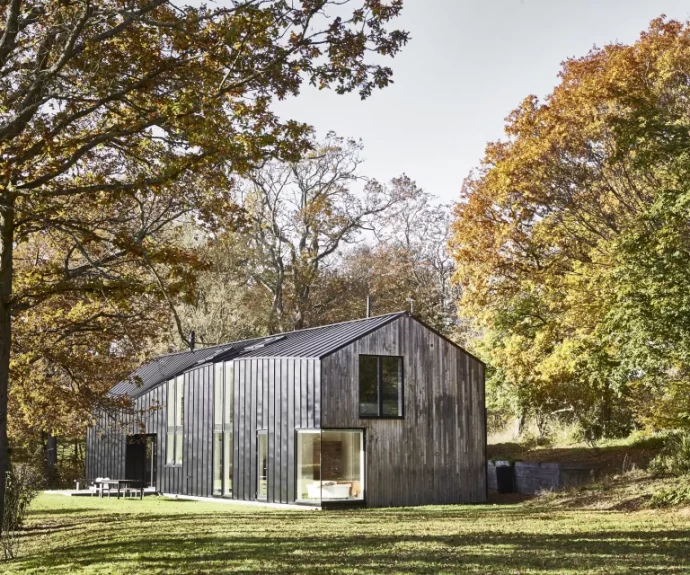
left=232, top=358, right=321, bottom=503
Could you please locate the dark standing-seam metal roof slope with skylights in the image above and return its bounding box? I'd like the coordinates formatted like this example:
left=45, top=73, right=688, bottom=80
left=110, top=312, right=406, bottom=398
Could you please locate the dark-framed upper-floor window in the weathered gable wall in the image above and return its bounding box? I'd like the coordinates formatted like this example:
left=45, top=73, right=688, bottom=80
left=359, top=355, right=403, bottom=417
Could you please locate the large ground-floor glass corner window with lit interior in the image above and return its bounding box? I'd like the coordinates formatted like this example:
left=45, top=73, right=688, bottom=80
left=296, top=429, right=364, bottom=503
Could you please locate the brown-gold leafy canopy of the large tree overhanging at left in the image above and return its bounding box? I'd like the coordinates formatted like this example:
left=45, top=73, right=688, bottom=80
left=0, top=0, right=408, bottom=528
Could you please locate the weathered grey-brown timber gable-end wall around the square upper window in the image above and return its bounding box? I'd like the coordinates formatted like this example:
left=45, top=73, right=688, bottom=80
left=321, top=316, right=486, bottom=507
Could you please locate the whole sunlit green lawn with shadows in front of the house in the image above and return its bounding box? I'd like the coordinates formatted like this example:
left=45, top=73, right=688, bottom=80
left=5, top=495, right=690, bottom=575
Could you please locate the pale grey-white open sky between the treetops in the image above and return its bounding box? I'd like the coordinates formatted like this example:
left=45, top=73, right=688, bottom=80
left=192, top=0, right=690, bottom=202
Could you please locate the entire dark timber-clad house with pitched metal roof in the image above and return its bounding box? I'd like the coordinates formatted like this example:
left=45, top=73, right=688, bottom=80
left=86, top=312, right=486, bottom=507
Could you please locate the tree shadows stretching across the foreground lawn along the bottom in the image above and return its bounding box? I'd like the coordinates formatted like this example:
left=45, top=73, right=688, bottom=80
left=10, top=515, right=690, bottom=575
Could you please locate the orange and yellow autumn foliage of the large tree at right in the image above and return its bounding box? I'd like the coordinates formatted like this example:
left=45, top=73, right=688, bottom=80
left=451, top=13, right=690, bottom=430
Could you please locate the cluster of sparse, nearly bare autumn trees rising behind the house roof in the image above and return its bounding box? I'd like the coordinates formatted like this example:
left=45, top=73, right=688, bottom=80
left=181, top=134, right=457, bottom=344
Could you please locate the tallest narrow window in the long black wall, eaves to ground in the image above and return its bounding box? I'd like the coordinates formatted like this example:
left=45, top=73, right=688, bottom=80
left=213, top=362, right=233, bottom=496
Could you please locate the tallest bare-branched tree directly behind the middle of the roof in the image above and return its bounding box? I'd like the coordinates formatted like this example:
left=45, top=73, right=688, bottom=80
left=231, top=134, right=416, bottom=331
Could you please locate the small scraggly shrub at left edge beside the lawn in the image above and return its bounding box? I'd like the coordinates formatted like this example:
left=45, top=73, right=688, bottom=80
left=0, top=464, right=41, bottom=560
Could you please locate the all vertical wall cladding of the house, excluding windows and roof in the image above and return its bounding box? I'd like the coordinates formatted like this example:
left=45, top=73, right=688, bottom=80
left=86, top=317, right=486, bottom=507
